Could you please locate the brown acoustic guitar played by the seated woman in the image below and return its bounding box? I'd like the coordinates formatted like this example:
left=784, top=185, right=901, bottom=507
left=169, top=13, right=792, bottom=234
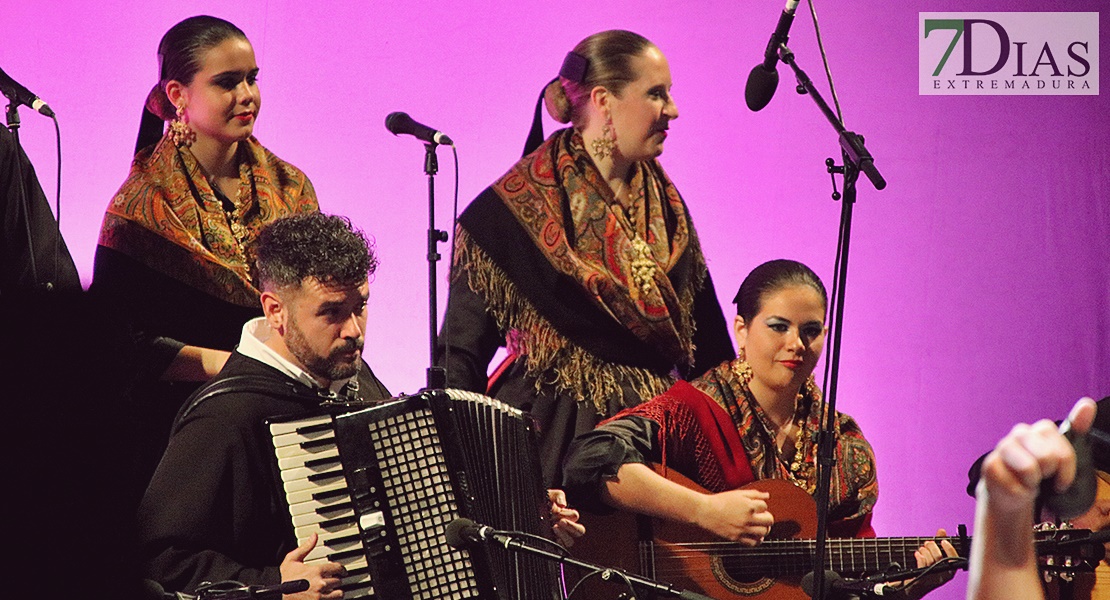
left=573, top=470, right=1102, bottom=600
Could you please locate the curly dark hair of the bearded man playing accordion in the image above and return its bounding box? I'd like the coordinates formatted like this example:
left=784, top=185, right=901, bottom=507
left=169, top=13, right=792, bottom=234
left=253, top=213, right=377, bottom=289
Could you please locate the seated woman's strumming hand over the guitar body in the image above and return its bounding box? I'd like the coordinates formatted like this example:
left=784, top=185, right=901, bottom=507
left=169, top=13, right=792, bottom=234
left=694, top=489, right=775, bottom=546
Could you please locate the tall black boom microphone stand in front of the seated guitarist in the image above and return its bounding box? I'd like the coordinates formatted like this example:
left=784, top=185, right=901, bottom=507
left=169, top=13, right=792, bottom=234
left=778, top=43, right=887, bottom=600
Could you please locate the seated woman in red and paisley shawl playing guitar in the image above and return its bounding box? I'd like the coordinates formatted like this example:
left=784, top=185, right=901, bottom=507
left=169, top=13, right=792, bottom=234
left=564, top=260, right=956, bottom=597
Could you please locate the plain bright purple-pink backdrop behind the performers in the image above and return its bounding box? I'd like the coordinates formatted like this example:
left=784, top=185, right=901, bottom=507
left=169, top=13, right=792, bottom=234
left=0, top=0, right=1110, bottom=598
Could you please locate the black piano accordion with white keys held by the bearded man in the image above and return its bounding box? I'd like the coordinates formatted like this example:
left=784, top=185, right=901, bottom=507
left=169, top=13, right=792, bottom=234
left=266, top=389, right=563, bottom=600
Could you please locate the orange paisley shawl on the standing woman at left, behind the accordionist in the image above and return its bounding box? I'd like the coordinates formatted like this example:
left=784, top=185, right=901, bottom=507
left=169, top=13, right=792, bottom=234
left=99, top=135, right=320, bottom=307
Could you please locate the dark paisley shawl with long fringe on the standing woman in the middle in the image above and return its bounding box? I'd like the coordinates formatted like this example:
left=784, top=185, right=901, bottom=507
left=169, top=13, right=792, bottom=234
left=455, top=130, right=719, bottom=415
